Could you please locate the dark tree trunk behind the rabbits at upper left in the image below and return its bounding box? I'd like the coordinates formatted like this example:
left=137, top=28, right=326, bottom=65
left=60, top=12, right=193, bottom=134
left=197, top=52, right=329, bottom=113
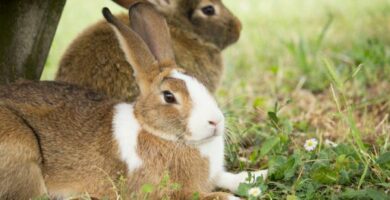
left=0, top=0, right=65, bottom=84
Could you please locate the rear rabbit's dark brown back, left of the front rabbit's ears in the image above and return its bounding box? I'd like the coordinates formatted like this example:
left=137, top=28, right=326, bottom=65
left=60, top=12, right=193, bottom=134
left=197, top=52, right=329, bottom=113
left=56, top=15, right=138, bottom=100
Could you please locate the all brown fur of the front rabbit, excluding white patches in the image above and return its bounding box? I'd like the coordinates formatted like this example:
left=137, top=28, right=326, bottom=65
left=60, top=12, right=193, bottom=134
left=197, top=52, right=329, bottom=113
left=0, top=5, right=235, bottom=200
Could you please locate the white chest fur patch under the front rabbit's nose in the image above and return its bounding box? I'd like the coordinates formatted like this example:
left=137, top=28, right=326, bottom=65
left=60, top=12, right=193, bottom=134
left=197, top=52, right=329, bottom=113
left=198, top=136, right=225, bottom=181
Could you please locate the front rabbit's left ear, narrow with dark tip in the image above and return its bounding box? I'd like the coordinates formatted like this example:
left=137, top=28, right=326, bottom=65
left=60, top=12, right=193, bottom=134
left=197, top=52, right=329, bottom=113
left=103, top=8, right=159, bottom=93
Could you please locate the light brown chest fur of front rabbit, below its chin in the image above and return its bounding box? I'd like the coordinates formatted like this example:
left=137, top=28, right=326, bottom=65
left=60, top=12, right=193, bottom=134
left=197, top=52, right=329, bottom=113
left=129, top=132, right=213, bottom=199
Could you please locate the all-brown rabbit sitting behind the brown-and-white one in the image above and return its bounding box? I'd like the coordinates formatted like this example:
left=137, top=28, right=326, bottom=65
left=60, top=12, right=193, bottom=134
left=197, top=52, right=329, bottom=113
left=56, top=0, right=241, bottom=101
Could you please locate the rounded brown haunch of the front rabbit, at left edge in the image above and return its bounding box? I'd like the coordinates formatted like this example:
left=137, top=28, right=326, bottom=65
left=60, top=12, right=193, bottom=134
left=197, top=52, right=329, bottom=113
left=0, top=105, right=46, bottom=200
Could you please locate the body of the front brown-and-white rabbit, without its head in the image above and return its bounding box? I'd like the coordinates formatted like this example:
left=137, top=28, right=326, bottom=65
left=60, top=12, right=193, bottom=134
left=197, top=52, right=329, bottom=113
left=0, top=82, right=227, bottom=199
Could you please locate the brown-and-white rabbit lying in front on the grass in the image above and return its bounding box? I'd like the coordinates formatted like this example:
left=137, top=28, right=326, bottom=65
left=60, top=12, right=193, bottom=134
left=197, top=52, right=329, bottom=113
left=0, top=3, right=267, bottom=200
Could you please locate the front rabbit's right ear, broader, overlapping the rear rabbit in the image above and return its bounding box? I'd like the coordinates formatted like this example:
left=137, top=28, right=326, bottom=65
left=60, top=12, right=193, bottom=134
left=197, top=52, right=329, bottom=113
left=129, top=0, right=175, bottom=67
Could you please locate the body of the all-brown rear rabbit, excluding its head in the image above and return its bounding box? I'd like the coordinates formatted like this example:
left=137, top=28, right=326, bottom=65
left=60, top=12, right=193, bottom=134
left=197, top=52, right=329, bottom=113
left=56, top=14, right=223, bottom=101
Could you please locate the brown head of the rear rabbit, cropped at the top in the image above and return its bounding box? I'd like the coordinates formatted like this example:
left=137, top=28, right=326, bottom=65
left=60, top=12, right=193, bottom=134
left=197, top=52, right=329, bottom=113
left=114, top=0, right=241, bottom=49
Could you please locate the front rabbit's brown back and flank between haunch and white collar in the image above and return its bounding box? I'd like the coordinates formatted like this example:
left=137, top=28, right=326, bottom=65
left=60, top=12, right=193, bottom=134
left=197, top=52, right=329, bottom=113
left=0, top=81, right=126, bottom=198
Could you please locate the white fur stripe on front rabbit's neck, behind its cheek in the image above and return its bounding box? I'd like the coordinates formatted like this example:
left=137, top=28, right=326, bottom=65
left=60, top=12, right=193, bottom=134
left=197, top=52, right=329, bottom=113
left=112, top=103, right=142, bottom=172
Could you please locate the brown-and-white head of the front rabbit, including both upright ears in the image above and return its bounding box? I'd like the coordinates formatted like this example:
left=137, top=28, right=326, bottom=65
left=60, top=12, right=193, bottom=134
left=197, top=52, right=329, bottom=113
left=103, top=3, right=224, bottom=143
